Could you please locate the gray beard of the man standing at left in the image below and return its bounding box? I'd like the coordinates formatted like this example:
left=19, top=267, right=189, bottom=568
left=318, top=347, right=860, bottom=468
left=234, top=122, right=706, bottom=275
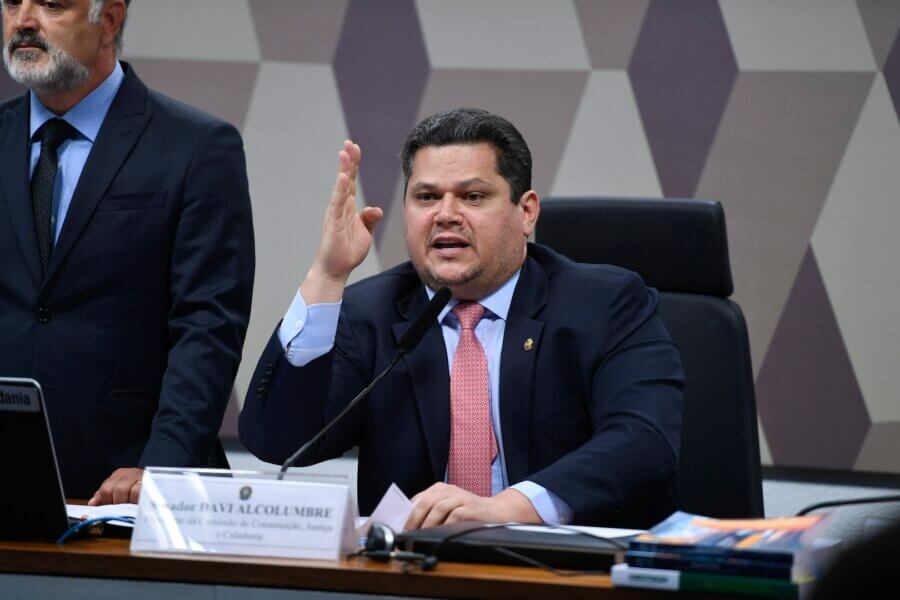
left=3, top=44, right=91, bottom=96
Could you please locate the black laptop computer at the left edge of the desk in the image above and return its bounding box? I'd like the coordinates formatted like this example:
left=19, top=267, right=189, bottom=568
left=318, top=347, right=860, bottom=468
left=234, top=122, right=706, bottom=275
left=0, top=377, right=77, bottom=539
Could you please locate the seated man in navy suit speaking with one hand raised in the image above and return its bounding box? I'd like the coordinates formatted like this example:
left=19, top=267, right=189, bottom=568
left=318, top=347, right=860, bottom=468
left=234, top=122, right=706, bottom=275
left=240, top=109, right=683, bottom=528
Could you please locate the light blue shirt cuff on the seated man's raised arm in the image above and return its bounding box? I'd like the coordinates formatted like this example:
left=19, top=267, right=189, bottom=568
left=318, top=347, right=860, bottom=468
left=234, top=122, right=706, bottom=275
left=278, top=290, right=341, bottom=367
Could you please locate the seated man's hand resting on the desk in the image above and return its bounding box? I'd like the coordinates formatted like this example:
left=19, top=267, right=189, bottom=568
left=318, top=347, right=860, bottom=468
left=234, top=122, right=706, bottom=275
left=406, top=483, right=542, bottom=529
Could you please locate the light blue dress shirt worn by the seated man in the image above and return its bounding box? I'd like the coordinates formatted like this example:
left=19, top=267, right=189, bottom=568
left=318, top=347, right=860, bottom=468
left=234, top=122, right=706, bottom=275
left=278, top=271, right=572, bottom=524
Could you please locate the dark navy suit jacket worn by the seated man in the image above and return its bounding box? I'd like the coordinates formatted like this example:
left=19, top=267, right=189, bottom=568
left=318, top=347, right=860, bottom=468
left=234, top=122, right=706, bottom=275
left=240, top=245, right=683, bottom=526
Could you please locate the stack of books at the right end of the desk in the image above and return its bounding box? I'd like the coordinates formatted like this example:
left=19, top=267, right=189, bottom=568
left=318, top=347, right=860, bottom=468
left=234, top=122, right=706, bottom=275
left=612, top=512, right=838, bottom=599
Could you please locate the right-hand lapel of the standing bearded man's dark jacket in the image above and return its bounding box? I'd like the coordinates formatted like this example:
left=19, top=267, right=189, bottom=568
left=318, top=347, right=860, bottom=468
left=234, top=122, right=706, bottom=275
left=44, top=68, right=150, bottom=282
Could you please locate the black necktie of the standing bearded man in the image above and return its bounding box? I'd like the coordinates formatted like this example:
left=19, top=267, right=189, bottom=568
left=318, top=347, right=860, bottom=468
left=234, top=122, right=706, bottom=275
left=31, top=119, right=76, bottom=273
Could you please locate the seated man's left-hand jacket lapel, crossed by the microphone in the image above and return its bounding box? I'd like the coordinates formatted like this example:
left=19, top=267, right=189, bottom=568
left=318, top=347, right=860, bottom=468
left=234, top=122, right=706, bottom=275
left=393, top=285, right=450, bottom=481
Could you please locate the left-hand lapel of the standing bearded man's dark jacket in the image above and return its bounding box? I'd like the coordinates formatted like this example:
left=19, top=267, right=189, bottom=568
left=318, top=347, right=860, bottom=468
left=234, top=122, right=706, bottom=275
left=0, top=94, right=43, bottom=282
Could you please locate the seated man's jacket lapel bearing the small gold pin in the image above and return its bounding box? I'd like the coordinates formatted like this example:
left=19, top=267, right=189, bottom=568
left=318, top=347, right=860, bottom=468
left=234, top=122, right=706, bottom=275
left=500, top=257, right=547, bottom=485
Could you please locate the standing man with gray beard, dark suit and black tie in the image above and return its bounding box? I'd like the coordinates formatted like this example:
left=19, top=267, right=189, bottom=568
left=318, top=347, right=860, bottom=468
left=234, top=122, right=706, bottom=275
left=0, top=0, right=254, bottom=504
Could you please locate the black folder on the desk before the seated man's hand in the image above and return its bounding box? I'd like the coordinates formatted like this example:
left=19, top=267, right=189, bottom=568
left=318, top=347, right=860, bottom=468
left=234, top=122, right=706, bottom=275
left=397, top=521, right=629, bottom=571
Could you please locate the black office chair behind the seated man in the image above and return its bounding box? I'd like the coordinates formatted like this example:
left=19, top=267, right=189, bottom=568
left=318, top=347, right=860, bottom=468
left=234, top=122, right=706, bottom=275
left=535, top=198, right=763, bottom=518
